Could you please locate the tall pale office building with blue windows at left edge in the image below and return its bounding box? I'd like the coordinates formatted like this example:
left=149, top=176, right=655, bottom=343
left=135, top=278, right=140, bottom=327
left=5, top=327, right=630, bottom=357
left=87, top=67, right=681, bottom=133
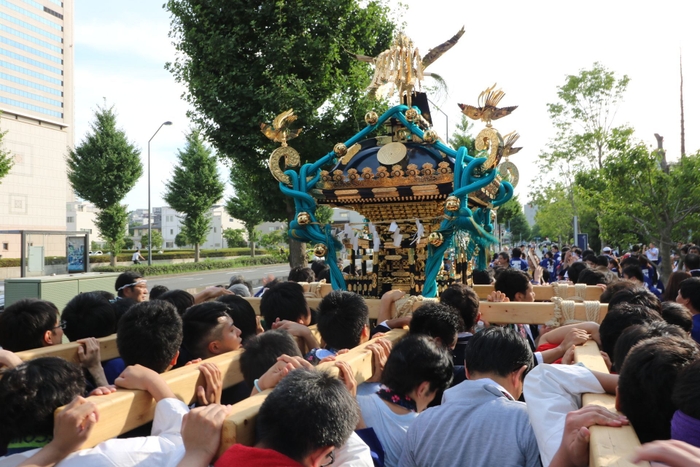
left=0, top=0, right=74, bottom=257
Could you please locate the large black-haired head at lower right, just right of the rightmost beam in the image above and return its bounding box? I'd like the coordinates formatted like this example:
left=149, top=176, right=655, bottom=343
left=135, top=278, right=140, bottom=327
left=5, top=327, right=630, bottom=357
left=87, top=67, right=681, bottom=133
left=616, top=336, right=700, bottom=443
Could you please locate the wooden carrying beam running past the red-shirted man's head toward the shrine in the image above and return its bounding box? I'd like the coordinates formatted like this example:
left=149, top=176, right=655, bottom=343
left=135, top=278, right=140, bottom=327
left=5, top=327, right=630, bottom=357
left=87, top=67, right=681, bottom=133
left=218, top=329, right=407, bottom=455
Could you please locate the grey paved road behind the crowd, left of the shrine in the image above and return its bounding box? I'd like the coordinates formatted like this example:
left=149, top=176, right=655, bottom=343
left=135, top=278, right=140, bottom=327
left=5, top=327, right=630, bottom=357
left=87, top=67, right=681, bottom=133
left=148, top=264, right=289, bottom=290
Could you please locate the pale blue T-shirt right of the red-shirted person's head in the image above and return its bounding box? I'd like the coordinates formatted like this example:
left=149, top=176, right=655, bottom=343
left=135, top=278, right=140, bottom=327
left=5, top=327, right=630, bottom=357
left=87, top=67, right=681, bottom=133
left=357, top=394, right=418, bottom=467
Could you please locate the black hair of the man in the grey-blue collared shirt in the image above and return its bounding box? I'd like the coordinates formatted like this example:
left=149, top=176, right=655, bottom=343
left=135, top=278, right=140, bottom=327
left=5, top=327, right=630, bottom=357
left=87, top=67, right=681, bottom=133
left=464, top=326, right=533, bottom=377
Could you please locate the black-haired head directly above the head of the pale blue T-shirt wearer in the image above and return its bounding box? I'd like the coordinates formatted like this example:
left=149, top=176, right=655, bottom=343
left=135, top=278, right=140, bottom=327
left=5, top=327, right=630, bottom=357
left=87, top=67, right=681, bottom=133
left=409, top=302, right=459, bottom=348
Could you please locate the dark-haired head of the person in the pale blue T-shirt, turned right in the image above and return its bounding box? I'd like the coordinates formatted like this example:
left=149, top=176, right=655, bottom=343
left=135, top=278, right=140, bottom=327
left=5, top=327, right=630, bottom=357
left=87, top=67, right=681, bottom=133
left=382, top=334, right=453, bottom=411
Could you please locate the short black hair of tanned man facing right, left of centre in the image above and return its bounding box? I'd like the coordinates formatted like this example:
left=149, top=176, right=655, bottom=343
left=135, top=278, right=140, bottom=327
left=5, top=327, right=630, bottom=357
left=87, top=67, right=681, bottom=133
left=182, top=301, right=234, bottom=359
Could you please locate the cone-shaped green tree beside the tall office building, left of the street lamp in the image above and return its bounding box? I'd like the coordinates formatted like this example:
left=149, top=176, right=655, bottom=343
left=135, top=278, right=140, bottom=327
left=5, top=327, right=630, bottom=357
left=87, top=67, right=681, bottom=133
left=67, top=107, right=143, bottom=265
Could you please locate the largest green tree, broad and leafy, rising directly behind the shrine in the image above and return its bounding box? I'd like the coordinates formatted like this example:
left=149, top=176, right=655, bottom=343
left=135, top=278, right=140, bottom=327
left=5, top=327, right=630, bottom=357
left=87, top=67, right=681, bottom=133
left=166, top=0, right=394, bottom=265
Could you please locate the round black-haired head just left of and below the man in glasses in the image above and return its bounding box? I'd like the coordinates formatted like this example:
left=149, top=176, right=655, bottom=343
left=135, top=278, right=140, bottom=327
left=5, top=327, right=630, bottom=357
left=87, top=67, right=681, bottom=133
left=61, top=292, right=117, bottom=341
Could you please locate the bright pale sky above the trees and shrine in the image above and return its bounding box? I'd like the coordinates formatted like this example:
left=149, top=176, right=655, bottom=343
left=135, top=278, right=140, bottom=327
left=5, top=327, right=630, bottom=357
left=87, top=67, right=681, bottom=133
left=74, top=0, right=700, bottom=210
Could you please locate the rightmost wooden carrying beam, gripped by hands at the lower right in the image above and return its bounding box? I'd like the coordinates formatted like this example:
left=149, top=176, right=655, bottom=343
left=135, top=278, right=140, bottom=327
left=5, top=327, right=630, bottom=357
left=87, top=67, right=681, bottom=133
left=575, top=340, right=649, bottom=467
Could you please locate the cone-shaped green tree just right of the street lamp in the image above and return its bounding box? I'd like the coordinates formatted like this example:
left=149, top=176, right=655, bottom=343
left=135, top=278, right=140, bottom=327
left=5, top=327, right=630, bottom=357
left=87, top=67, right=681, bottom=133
left=163, top=129, right=224, bottom=262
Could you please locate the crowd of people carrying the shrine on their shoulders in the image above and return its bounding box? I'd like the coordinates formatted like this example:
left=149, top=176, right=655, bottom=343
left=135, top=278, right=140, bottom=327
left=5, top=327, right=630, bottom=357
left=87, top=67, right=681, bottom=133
left=0, top=245, right=700, bottom=467
